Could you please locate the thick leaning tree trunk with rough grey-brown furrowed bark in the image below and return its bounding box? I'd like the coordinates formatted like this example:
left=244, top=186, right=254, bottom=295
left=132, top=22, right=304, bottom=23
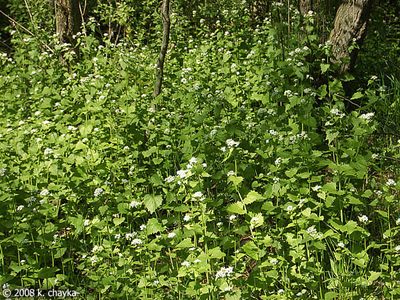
left=329, top=0, right=373, bottom=74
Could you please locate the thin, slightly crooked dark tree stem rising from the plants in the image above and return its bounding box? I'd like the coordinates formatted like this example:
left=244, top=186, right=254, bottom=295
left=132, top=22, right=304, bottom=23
left=153, top=0, right=171, bottom=97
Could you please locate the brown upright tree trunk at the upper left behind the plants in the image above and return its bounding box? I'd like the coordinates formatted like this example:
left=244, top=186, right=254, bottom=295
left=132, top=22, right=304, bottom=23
left=55, top=0, right=81, bottom=44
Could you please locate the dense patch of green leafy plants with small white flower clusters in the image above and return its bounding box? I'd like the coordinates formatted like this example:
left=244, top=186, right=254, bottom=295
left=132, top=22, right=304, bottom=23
left=0, top=4, right=400, bottom=299
